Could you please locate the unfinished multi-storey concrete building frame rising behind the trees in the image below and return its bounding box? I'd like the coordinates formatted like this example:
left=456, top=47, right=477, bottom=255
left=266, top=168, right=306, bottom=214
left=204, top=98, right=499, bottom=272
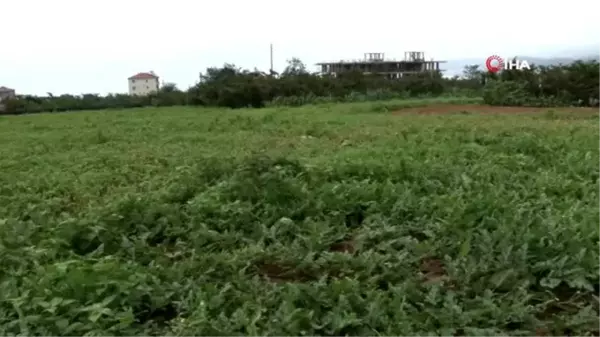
left=317, top=51, right=446, bottom=79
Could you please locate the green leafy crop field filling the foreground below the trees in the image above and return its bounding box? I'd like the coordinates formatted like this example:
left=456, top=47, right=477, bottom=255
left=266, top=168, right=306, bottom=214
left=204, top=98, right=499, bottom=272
left=0, top=100, right=600, bottom=337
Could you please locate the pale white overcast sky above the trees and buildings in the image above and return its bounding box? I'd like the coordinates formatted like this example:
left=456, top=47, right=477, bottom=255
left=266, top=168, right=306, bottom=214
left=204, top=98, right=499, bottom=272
left=0, top=0, right=600, bottom=95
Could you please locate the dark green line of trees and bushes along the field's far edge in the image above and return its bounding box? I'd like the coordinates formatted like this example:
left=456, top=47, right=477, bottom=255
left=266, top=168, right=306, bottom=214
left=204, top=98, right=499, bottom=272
left=2, top=59, right=600, bottom=114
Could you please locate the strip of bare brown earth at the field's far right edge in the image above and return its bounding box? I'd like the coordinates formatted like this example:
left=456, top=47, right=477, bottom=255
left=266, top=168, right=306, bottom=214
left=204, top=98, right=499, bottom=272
left=394, top=104, right=600, bottom=114
